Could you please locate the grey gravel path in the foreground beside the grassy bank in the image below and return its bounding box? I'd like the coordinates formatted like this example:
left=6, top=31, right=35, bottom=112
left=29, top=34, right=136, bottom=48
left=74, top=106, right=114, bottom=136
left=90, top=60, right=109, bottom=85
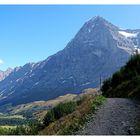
left=77, top=98, right=140, bottom=135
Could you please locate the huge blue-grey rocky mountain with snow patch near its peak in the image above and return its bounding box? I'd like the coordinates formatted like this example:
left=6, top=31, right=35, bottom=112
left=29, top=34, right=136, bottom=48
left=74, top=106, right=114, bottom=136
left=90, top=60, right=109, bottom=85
left=0, top=16, right=140, bottom=105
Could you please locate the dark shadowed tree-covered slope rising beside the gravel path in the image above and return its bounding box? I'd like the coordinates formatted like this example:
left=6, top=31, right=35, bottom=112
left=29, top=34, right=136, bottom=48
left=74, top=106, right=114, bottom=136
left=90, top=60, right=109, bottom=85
left=102, top=54, right=140, bottom=100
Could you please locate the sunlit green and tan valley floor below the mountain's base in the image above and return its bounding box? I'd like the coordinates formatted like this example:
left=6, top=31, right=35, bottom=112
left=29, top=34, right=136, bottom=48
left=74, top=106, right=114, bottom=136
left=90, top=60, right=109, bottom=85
left=0, top=94, right=77, bottom=127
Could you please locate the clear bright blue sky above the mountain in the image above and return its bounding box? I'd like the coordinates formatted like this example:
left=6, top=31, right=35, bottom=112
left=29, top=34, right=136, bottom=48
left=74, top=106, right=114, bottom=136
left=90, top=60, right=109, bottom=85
left=0, top=5, right=140, bottom=70
